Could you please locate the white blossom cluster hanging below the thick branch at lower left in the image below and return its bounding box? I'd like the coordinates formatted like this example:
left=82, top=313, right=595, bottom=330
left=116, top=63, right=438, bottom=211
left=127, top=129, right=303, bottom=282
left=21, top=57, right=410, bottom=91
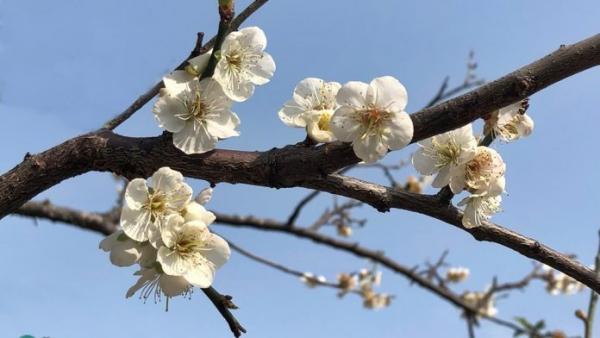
left=100, top=167, right=231, bottom=305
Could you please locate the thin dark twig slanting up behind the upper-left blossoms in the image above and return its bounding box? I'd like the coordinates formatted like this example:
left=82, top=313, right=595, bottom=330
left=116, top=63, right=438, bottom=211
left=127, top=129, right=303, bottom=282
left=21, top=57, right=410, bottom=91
left=102, top=0, right=268, bottom=130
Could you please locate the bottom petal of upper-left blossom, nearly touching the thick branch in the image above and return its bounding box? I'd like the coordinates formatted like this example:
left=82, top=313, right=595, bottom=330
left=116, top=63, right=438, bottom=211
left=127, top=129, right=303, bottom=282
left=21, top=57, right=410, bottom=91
left=173, top=122, right=219, bottom=154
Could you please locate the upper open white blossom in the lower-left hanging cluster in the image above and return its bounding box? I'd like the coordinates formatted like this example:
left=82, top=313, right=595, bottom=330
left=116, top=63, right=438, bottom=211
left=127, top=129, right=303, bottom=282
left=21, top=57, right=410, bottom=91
left=120, top=167, right=192, bottom=245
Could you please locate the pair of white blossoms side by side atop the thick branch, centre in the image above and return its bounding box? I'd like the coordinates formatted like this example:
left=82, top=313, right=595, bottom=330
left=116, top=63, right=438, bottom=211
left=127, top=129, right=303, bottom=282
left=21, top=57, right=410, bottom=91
left=278, top=76, right=413, bottom=163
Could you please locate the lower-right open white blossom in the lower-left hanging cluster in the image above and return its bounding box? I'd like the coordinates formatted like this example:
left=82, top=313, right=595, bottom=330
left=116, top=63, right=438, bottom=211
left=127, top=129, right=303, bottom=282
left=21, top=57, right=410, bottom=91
left=157, top=214, right=231, bottom=288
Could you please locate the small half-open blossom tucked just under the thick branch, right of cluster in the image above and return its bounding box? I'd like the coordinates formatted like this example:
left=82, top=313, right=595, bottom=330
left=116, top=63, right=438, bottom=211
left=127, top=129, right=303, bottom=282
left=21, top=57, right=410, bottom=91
left=486, top=100, right=534, bottom=142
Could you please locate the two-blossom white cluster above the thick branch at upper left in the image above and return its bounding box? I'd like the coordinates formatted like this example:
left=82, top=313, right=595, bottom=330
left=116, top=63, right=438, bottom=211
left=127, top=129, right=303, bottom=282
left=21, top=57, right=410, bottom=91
left=153, top=27, right=275, bottom=154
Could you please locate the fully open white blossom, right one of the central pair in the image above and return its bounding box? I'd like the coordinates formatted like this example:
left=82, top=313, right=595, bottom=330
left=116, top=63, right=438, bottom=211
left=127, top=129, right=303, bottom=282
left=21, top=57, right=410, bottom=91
left=330, top=76, right=413, bottom=163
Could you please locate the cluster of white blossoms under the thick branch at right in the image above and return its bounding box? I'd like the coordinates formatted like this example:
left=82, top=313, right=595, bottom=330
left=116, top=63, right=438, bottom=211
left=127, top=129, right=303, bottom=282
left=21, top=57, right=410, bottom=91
left=412, top=101, right=533, bottom=228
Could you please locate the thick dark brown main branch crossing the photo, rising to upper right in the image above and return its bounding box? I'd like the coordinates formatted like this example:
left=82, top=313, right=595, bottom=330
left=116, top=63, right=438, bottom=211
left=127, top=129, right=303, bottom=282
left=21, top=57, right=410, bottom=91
left=5, top=34, right=600, bottom=222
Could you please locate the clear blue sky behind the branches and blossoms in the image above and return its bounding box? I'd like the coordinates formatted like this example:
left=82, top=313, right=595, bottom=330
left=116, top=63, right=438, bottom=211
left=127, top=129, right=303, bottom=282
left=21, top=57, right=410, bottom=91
left=0, top=0, right=600, bottom=338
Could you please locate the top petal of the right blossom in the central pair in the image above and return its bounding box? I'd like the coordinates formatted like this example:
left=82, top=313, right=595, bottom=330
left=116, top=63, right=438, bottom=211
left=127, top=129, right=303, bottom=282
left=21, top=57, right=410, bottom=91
left=368, top=76, right=412, bottom=110
